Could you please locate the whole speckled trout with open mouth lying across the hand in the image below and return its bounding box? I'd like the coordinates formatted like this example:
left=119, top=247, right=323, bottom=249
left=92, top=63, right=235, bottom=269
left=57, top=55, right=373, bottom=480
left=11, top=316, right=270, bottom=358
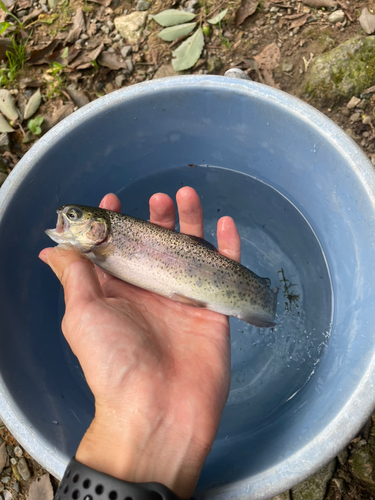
left=45, top=205, right=278, bottom=328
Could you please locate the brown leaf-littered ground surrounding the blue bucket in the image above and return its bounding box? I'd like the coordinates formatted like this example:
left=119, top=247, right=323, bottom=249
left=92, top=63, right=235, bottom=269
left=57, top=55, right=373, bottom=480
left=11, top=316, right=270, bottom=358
left=0, top=0, right=375, bottom=500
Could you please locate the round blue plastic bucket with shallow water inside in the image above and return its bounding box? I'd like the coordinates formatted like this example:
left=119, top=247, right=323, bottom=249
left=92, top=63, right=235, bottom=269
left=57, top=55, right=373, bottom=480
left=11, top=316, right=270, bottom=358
left=0, top=76, right=375, bottom=500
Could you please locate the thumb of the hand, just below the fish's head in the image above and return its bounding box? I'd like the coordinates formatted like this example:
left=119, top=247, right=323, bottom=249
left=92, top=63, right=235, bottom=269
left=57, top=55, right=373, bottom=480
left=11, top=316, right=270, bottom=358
left=39, top=243, right=103, bottom=307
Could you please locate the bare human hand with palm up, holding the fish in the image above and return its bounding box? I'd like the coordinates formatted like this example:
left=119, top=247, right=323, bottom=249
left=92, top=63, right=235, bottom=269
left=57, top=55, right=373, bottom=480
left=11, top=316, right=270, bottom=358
left=40, top=187, right=240, bottom=498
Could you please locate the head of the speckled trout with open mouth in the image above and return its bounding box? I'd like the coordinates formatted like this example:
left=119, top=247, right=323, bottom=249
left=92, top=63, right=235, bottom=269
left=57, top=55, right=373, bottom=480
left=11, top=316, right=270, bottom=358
left=45, top=205, right=110, bottom=253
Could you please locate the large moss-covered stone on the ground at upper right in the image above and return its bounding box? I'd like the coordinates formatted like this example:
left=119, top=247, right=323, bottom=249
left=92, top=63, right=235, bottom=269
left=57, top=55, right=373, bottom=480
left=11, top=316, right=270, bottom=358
left=305, top=36, right=375, bottom=107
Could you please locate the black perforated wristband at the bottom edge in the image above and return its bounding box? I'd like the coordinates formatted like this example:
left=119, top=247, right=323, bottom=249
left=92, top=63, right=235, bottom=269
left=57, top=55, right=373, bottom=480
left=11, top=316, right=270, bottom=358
left=55, top=458, right=184, bottom=500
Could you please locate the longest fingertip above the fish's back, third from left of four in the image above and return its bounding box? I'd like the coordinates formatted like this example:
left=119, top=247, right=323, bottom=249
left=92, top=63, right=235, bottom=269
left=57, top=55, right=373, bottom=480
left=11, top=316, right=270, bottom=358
left=176, top=186, right=204, bottom=238
